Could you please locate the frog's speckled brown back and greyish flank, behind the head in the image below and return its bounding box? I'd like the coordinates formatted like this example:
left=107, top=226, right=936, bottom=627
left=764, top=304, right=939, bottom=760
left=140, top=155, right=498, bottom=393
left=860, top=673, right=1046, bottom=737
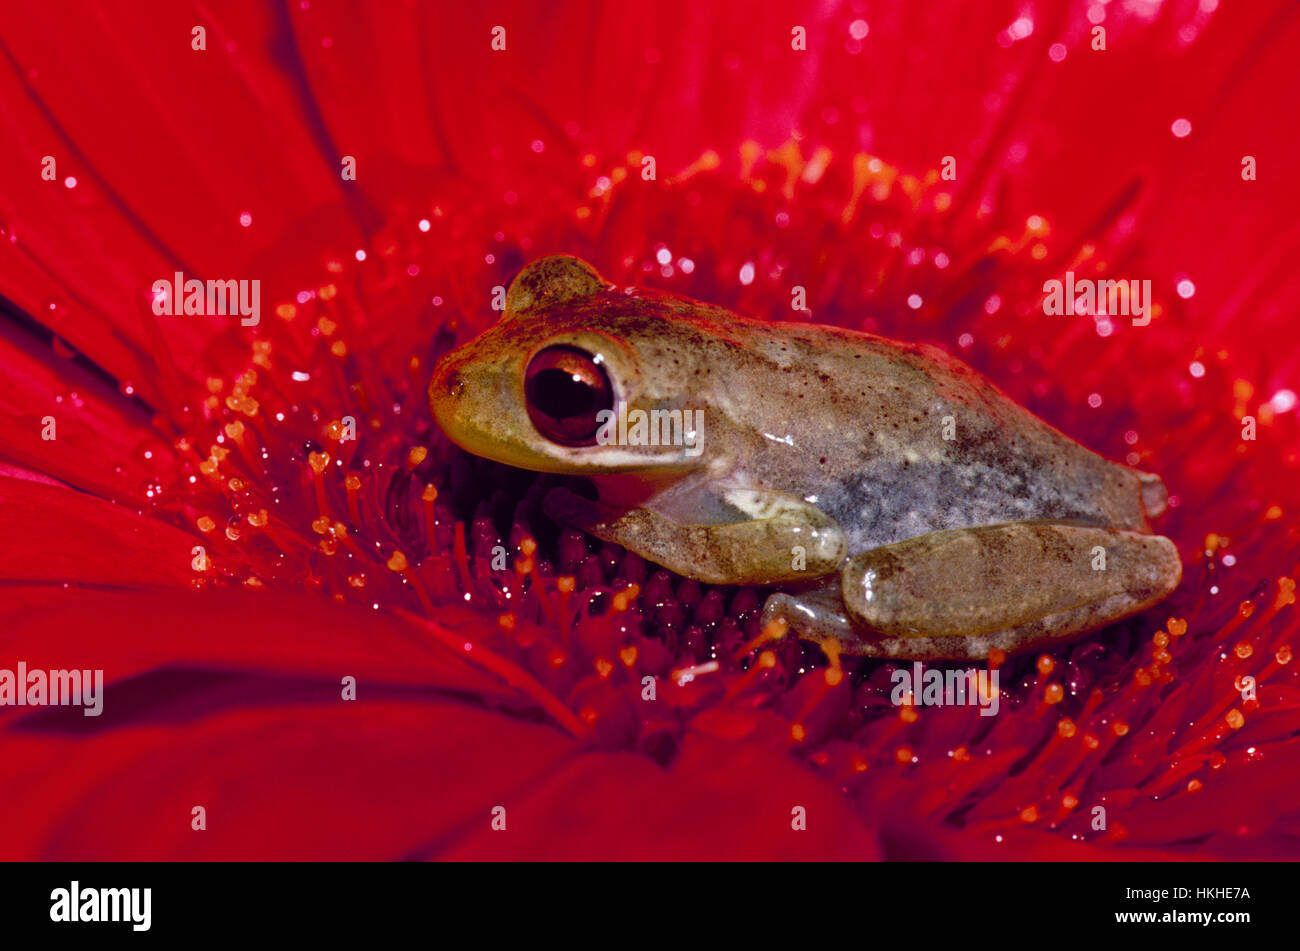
left=702, top=321, right=1164, bottom=551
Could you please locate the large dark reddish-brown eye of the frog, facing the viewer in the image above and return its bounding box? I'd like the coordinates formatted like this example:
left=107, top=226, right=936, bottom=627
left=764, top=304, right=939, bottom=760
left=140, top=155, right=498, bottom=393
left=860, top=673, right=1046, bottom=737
left=524, top=346, right=614, bottom=446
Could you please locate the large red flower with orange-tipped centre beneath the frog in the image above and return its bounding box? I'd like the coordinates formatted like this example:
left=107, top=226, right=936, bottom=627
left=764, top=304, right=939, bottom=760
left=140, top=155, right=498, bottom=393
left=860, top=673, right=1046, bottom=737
left=0, top=0, right=1300, bottom=859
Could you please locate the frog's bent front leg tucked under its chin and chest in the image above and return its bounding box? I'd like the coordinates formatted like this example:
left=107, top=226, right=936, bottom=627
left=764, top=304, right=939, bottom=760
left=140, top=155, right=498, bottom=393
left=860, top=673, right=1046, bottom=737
left=545, top=488, right=848, bottom=585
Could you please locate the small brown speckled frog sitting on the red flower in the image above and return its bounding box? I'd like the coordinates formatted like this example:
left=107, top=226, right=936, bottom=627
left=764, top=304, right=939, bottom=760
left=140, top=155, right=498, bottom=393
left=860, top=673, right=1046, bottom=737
left=428, top=253, right=1182, bottom=661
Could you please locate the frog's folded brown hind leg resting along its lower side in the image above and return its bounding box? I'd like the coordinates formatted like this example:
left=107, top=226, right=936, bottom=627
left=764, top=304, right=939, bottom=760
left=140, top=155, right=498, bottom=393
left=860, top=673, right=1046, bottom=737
left=826, top=522, right=1182, bottom=659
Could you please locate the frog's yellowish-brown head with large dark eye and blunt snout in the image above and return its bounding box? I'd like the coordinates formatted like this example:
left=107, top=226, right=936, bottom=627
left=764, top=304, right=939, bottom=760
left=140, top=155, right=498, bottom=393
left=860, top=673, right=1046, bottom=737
left=429, top=255, right=703, bottom=476
